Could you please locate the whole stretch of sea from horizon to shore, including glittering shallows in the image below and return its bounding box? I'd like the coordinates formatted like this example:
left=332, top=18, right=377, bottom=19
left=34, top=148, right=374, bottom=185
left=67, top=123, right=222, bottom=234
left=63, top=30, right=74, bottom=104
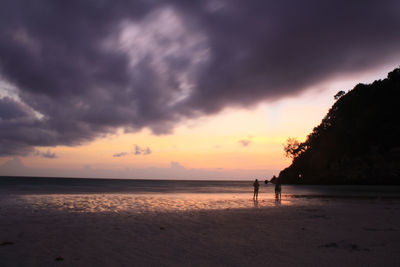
left=0, top=177, right=400, bottom=214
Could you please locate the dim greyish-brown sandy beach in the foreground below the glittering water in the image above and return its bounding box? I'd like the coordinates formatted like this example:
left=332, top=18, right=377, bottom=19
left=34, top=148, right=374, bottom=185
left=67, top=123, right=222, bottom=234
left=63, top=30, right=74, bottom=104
left=0, top=197, right=400, bottom=266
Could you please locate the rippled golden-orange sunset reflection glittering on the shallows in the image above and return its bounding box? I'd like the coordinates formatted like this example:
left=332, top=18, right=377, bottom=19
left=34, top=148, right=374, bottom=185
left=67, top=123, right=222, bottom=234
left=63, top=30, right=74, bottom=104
left=11, top=194, right=292, bottom=213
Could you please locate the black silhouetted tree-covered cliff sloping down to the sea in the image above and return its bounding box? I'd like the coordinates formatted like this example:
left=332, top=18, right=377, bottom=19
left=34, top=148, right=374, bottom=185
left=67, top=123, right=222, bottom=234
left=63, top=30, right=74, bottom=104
left=279, top=68, right=400, bottom=184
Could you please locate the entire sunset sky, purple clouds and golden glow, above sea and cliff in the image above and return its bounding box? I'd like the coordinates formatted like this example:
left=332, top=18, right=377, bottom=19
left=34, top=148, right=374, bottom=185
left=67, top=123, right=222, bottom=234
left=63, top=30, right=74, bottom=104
left=0, top=0, right=400, bottom=179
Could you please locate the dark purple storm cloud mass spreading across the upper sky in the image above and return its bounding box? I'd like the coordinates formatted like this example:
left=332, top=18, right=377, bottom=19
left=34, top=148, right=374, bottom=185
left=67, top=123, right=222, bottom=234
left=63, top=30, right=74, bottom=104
left=0, top=0, right=400, bottom=155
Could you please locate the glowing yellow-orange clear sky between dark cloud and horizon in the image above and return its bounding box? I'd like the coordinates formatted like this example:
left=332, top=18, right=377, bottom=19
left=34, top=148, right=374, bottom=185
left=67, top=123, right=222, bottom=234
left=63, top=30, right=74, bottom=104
left=0, top=63, right=396, bottom=179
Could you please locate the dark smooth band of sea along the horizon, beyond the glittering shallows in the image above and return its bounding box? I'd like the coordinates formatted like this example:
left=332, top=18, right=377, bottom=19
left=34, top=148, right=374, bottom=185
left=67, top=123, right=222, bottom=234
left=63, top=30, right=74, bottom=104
left=0, top=176, right=400, bottom=198
